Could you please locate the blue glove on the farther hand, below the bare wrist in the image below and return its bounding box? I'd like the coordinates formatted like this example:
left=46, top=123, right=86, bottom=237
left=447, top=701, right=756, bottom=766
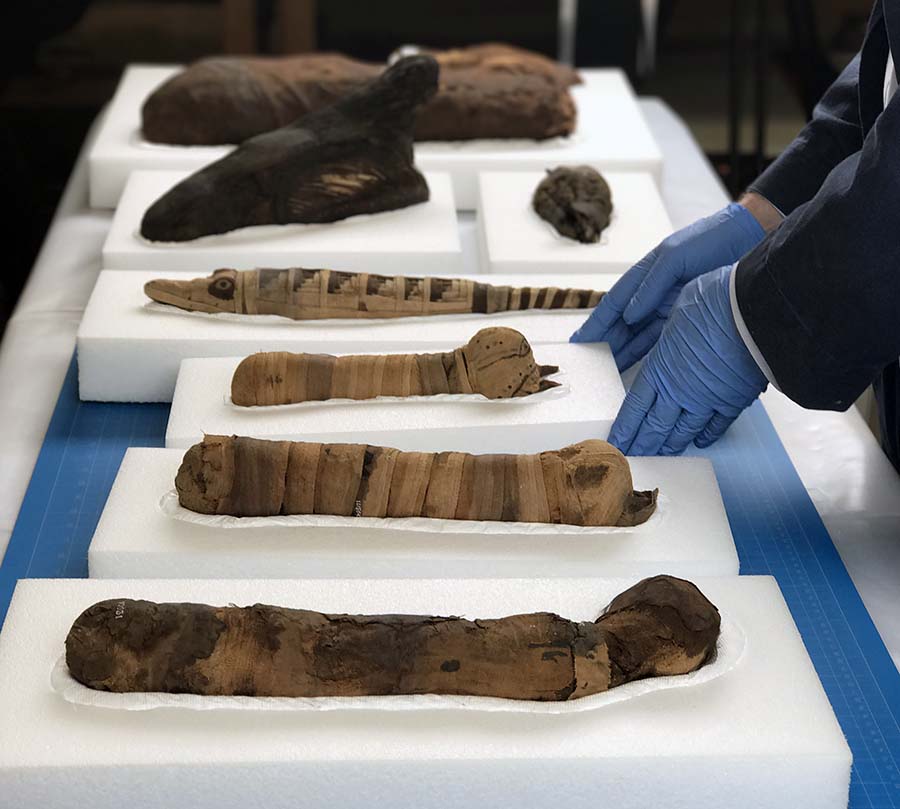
left=570, top=202, right=765, bottom=371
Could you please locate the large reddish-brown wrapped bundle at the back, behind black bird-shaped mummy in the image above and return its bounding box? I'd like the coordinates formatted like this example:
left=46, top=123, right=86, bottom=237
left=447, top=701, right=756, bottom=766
left=141, top=43, right=580, bottom=145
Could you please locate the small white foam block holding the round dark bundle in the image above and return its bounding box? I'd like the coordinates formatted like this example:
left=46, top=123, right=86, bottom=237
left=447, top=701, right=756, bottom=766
left=478, top=171, right=672, bottom=275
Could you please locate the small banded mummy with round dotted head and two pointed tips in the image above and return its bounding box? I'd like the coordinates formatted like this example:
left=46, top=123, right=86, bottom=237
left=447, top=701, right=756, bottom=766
left=231, top=327, right=559, bottom=407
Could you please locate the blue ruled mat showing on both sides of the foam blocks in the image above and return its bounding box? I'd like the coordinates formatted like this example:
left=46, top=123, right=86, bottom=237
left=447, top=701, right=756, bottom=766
left=0, top=361, right=900, bottom=809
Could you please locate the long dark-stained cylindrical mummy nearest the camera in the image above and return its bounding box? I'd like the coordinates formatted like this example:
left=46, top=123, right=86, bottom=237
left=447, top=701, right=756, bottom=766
left=66, top=576, right=721, bottom=702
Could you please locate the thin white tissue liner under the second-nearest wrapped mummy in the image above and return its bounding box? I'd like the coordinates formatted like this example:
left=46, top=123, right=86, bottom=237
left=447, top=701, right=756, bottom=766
left=159, top=489, right=669, bottom=539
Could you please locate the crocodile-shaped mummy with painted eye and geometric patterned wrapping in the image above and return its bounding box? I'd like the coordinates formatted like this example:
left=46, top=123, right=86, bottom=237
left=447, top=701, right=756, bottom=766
left=144, top=267, right=605, bottom=320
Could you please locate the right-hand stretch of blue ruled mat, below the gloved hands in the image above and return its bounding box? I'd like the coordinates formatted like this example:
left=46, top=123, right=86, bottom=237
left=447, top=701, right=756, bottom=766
left=689, top=402, right=900, bottom=809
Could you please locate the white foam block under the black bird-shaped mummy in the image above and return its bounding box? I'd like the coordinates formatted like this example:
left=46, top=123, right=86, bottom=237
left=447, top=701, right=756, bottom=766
left=103, top=171, right=462, bottom=275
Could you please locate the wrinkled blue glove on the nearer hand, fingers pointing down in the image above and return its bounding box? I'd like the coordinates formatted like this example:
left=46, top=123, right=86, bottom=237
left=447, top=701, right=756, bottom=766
left=609, top=266, right=768, bottom=455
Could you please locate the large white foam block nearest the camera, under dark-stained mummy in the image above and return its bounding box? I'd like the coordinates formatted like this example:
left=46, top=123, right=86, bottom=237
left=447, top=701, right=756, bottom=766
left=0, top=577, right=851, bottom=809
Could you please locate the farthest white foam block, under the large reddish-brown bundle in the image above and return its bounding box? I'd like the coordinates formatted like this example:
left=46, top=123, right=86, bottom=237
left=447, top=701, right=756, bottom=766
left=88, top=65, right=662, bottom=210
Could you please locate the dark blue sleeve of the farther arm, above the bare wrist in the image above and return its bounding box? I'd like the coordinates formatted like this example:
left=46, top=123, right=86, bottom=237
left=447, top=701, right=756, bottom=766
left=749, top=54, right=862, bottom=215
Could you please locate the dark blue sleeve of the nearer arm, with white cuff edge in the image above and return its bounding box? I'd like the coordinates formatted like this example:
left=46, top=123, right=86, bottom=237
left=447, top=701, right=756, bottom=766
left=735, top=84, right=900, bottom=410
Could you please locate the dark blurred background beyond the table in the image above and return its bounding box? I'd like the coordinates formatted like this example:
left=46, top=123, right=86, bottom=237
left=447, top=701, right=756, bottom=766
left=0, top=0, right=871, bottom=329
